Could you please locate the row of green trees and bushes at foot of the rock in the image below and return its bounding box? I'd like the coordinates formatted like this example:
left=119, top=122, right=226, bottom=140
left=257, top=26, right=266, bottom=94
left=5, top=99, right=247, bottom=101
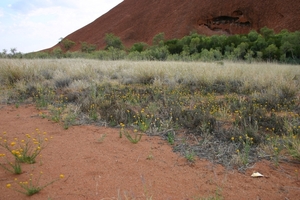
left=2, top=27, right=300, bottom=64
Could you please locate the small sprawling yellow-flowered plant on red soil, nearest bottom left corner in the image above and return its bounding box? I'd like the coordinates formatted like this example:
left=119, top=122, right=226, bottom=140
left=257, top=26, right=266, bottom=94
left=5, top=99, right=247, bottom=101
left=6, top=172, right=64, bottom=196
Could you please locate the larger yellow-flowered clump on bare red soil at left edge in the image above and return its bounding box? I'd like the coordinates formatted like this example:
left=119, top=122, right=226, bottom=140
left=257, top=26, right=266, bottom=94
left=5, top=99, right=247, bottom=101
left=0, top=129, right=48, bottom=164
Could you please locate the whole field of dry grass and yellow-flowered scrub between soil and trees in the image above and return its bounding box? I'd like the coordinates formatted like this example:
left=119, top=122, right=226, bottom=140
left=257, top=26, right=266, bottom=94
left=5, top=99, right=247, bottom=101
left=0, top=59, right=300, bottom=170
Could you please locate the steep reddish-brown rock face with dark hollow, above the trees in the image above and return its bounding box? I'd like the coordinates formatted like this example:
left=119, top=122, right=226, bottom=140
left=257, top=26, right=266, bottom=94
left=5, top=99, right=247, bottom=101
left=48, top=0, right=300, bottom=51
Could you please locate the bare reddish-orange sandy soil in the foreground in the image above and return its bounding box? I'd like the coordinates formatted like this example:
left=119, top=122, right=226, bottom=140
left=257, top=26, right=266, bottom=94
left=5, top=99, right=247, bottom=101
left=0, top=105, right=300, bottom=200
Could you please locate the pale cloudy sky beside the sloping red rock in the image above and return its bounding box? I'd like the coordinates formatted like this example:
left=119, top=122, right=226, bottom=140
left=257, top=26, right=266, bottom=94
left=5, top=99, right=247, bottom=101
left=0, top=0, right=122, bottom=53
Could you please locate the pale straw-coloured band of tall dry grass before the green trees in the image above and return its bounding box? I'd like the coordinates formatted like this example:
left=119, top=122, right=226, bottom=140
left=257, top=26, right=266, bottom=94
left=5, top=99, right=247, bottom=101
left=0, top=59, right=300, bottom=88
